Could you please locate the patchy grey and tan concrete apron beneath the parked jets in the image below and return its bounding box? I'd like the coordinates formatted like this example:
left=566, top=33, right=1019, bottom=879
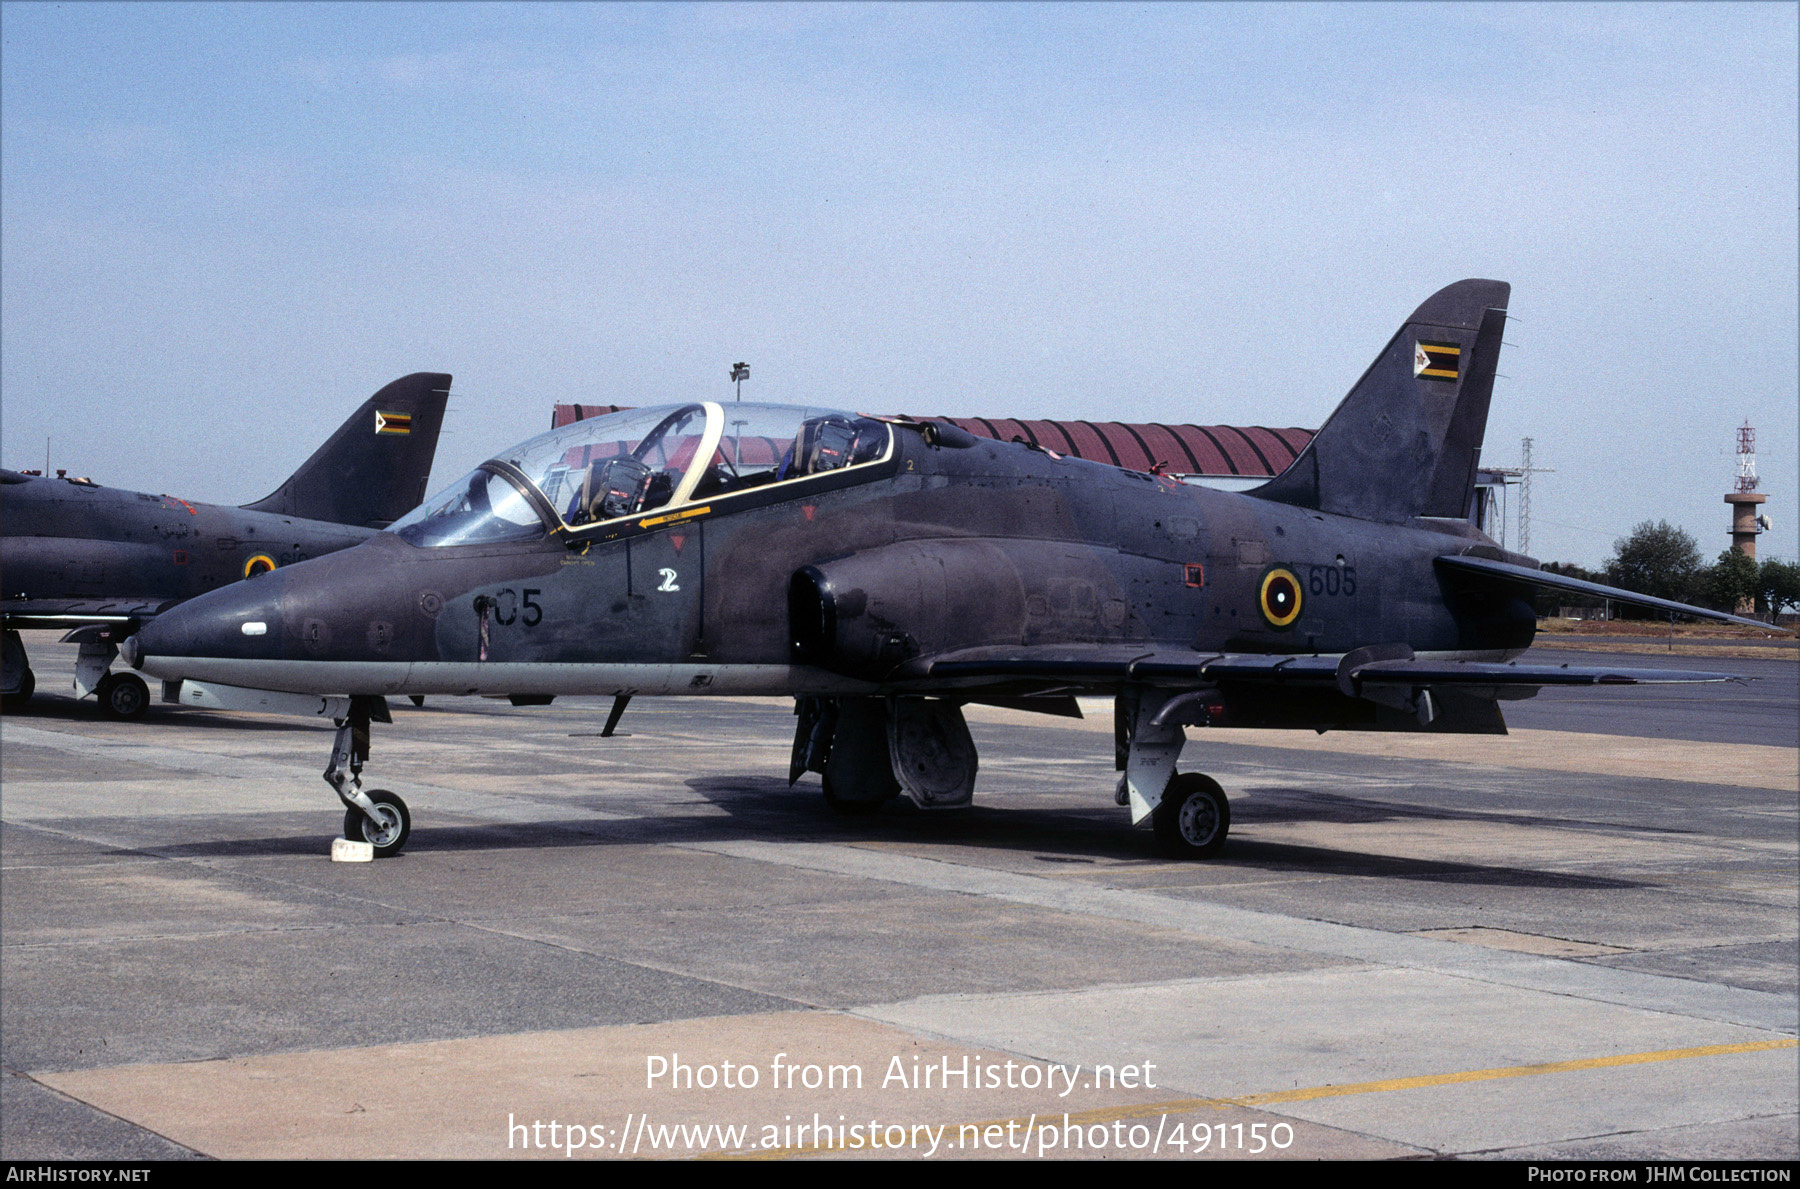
left=0, top=633, right=1800, bottom=1160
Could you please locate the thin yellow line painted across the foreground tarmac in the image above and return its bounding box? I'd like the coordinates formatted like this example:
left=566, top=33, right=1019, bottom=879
left=700, top=1036, right=1800, bottom=1160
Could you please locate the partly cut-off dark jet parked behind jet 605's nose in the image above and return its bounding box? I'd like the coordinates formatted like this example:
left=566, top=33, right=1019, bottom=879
left=0, top=372, right=450, bottom=718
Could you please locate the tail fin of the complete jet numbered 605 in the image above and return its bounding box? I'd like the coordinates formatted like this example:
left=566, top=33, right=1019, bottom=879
left=1249, top=281, right=1512, bottom=522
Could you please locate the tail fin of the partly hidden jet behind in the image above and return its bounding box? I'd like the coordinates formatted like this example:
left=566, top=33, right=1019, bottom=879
left=243, top=372, right=450, bottom=529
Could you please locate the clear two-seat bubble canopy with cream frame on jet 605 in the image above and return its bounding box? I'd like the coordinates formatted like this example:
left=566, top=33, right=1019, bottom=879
left=387, top=401, right=893, bottom=547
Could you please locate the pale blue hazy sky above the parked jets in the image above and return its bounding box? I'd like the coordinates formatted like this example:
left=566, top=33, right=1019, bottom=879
left=0, top=4, right=1800, bottom=565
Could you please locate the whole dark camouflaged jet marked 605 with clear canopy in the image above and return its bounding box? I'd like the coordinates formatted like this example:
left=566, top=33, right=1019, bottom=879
left=124, top=281, right=1762, bottom=856
